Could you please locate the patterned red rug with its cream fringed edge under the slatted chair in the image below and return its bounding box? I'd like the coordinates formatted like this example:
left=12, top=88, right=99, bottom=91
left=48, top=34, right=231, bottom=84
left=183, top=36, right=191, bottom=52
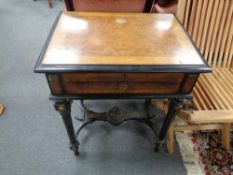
left=176, top=119, right=233, bottom=175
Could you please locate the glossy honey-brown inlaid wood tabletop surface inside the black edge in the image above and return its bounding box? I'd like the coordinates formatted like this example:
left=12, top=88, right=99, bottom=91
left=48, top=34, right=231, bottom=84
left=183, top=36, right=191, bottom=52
left=42, top=12, right=204, bottom=65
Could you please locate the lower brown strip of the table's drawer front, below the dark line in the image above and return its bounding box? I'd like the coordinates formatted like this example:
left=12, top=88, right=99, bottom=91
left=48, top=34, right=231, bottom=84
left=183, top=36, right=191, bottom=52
left=65, top=82, right=180, bottom=94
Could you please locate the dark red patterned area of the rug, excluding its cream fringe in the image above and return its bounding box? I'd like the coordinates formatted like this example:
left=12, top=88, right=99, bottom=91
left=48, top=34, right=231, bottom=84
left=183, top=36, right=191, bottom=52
left=189, top=131, right=233, bottom=175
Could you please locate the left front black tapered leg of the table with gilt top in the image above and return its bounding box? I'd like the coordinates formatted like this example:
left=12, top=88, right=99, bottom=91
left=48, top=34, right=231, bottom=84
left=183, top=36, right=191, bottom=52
left=54, top=100, right=79, bottom=155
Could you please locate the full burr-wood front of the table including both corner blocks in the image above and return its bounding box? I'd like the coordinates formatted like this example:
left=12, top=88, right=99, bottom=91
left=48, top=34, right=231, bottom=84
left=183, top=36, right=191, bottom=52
left=47, top=73, right=198, bottom=95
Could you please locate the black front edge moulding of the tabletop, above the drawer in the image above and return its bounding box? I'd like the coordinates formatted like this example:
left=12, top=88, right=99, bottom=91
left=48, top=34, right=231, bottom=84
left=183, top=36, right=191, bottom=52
left=34, top=64, right=211, bottom=73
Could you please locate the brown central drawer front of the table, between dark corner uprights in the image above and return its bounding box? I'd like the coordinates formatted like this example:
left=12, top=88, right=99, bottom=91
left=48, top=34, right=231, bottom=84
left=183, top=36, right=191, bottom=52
left=59, top=73, right=184, bottom=95
